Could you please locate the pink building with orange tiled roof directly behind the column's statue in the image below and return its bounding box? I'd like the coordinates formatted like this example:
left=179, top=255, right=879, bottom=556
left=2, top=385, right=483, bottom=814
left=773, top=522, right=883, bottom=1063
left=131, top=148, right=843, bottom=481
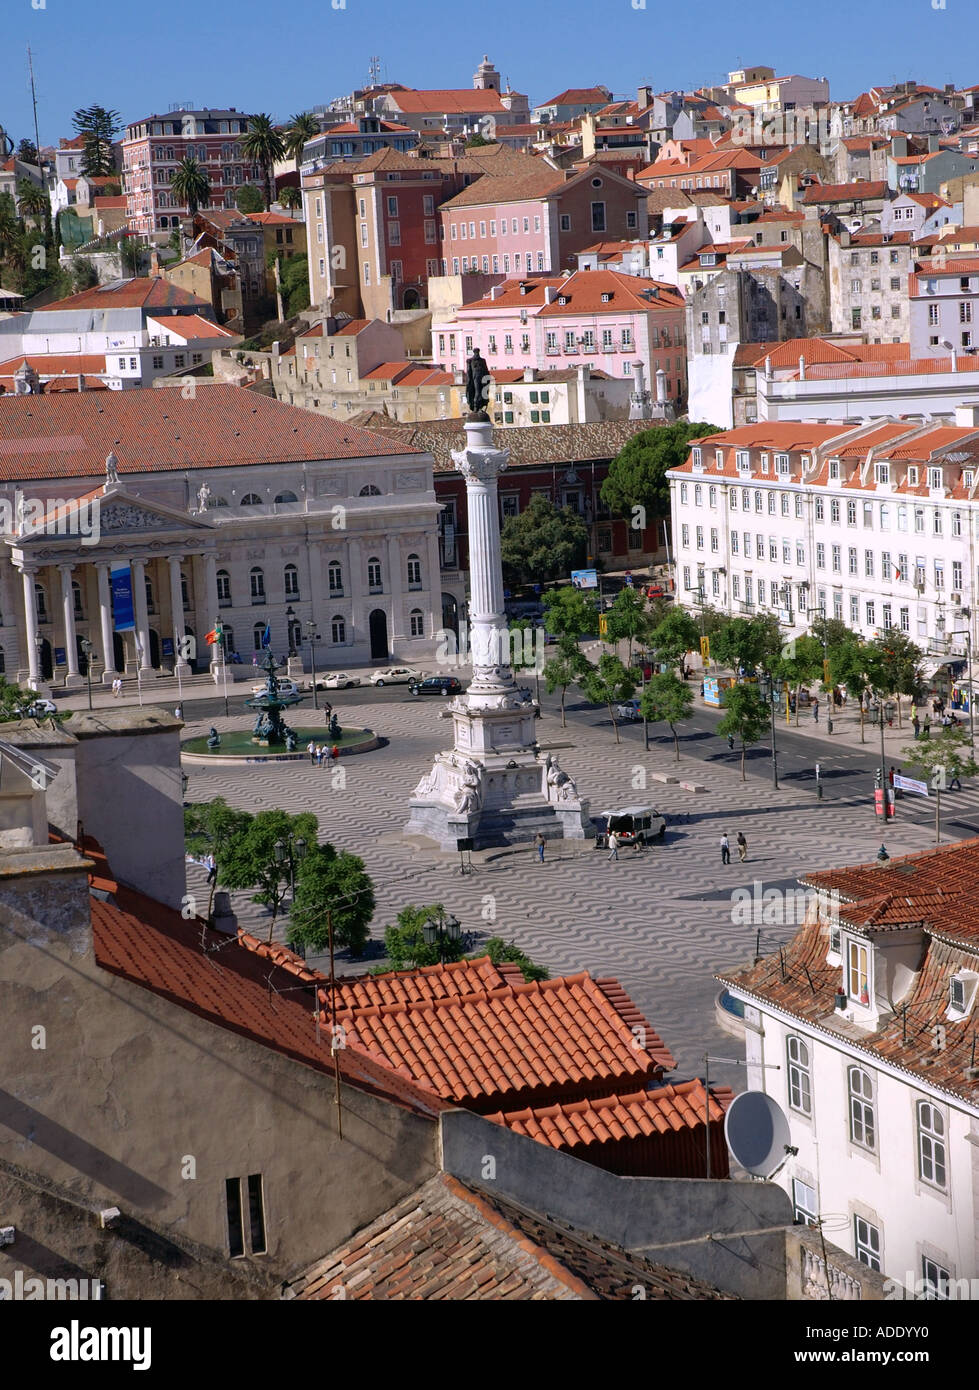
left=432, top=270, right=687, bottom=402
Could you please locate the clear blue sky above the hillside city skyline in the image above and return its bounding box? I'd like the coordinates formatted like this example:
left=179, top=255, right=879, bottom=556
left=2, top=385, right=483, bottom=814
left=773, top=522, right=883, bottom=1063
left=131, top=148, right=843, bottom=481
left=0, top=0, right=979, bottom=145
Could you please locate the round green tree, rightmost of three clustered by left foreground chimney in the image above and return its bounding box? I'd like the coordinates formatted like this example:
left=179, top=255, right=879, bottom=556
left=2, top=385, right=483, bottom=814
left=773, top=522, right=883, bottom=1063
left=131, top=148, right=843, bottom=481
left=289, top=839, right=374, bottom=956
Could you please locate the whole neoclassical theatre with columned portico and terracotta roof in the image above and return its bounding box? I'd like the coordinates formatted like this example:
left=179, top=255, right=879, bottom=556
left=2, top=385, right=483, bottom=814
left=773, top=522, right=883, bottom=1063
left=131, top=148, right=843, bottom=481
left=0, top=384, right=442, bottom=688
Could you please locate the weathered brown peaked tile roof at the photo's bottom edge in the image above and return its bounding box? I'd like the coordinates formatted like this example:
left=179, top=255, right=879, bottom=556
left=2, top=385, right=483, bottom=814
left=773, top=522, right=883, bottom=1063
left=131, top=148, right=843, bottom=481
left=284, top=1173, right=726, bottom=1302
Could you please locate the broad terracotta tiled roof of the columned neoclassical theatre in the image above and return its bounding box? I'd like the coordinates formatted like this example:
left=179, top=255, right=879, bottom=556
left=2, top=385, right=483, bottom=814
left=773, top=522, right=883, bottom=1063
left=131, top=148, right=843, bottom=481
left=0, top=385, right=413, bottom=482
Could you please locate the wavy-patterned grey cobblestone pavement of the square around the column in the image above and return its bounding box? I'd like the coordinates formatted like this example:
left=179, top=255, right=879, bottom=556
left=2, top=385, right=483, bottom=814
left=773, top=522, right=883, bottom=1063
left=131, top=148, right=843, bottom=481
left=186, top=698, right=956, bottom=1086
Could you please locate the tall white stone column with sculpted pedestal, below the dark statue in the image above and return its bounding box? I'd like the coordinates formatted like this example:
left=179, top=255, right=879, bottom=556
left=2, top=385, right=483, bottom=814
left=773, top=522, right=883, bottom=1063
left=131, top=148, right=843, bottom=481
left=405, top=417, right=591, bottom=849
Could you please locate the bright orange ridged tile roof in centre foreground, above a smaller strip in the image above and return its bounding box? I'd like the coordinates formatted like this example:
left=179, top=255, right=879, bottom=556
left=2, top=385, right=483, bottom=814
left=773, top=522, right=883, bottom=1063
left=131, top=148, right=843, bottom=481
left=328, top=972, right=676, bottom=1111
